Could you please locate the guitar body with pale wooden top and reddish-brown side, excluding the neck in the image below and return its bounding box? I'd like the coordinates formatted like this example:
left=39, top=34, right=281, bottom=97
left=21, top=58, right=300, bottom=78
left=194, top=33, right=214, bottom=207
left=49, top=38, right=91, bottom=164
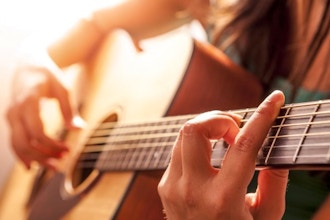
left=0, top=30, right=262, bottom=219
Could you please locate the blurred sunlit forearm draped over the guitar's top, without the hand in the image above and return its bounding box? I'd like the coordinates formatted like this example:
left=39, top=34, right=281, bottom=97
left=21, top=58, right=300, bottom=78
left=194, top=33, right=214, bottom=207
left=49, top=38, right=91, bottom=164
left=48, top=0, right=191, bottom=67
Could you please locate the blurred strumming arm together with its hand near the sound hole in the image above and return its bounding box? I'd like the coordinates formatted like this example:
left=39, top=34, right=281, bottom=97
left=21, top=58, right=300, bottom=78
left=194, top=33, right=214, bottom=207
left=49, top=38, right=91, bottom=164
left=7, top=0, right=208, bottom=167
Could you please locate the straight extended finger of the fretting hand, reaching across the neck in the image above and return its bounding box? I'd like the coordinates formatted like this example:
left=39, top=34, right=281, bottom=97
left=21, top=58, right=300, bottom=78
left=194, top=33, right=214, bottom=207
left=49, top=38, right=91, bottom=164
left=222, top=91, right=284, bottom=188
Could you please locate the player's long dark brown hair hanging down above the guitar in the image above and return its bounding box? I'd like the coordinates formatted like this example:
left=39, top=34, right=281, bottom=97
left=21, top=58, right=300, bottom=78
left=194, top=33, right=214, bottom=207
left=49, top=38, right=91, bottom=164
left=211, top=0, right=330, bottom=96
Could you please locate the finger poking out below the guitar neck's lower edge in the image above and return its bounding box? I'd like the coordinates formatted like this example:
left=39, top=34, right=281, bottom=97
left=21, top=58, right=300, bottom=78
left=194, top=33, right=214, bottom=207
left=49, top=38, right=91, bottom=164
left=254, top=170, right=289, bottom=219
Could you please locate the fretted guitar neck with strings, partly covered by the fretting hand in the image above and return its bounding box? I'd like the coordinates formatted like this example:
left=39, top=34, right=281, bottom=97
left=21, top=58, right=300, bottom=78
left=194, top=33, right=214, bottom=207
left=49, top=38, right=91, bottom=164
left=78, top=100, right=330, bottom=171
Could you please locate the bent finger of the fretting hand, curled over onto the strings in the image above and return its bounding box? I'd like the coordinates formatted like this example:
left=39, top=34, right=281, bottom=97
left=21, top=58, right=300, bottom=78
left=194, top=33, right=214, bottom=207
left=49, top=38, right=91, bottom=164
left=182, top=113, right=239, bottom=179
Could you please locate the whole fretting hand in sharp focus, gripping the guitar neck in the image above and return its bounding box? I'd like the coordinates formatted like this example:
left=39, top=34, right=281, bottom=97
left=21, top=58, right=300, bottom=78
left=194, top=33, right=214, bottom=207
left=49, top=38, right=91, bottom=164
left=158, top=92, right=288, bottom=219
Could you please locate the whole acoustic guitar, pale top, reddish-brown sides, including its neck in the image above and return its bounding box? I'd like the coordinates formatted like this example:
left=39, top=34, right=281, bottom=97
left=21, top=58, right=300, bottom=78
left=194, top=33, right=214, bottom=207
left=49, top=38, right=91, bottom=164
left=0, top=31, right=330, bottom=220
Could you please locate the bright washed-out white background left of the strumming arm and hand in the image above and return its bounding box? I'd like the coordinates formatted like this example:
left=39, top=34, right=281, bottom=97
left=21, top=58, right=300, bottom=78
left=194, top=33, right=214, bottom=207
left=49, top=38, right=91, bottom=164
left=0, top=0, right=120, bottom=191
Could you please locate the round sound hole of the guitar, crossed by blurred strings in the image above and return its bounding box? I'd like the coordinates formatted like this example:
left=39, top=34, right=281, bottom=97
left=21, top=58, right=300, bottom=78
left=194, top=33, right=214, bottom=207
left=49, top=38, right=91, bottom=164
left=72, top=114, right=118, bottom=188
